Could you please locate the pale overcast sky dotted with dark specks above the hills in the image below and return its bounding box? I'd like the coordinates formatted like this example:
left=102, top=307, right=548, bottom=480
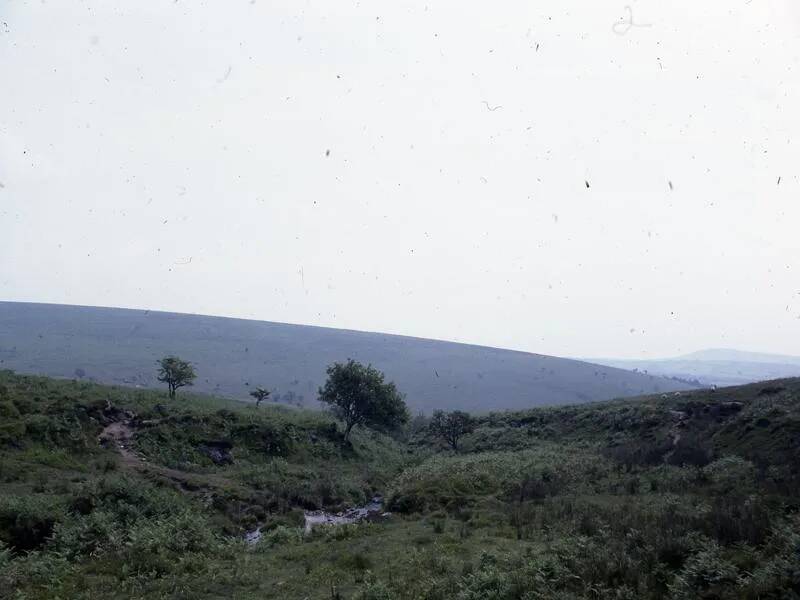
left=0, top=0, right=800, bottom=358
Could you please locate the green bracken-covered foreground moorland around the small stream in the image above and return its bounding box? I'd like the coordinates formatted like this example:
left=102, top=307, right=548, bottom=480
left=0, top=372, right=800, bottom=600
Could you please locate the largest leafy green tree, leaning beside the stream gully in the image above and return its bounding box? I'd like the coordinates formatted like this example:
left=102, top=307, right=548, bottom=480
left=319, top=359, right=409, bottom=441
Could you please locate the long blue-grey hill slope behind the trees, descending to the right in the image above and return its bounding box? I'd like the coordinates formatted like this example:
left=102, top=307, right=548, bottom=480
left=0, top=302, right=690, bottom=413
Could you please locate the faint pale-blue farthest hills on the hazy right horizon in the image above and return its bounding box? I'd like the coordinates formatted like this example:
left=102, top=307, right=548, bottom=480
left=591, top=348, right=800, bottom=386
